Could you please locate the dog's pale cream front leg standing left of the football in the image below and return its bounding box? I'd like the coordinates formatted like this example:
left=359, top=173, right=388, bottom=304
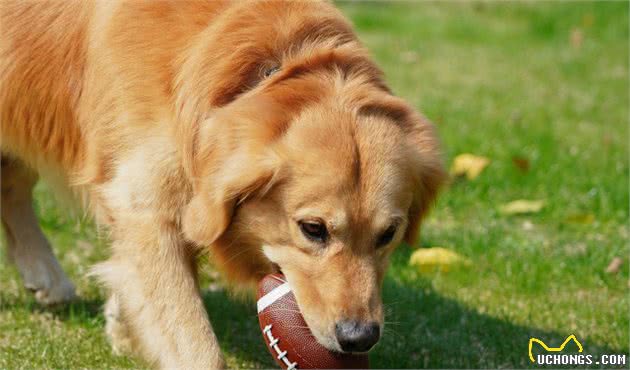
left=95, top=220, right=224, bottom=369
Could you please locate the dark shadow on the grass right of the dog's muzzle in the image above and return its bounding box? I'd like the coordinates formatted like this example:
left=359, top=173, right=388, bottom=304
left=371, top=280, right=619, bottom=368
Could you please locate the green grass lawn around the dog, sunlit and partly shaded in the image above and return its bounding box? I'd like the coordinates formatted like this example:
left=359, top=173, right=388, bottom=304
left=0, top=2, right=630, bottom=368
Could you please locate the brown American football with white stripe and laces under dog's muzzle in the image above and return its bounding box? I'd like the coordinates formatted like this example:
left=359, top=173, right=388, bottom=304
left=257, top=274, right=369, bottom=370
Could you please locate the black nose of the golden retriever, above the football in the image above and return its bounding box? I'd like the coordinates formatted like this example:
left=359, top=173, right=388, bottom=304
left=335, top=320, right=381, bottom=352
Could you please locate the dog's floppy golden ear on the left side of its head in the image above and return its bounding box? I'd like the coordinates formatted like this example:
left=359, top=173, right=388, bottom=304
left=182, top=120, right=280, bottom=245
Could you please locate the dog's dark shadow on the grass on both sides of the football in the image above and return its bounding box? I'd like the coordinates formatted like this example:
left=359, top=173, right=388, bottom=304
left=204, top=268, right=620, bottom=368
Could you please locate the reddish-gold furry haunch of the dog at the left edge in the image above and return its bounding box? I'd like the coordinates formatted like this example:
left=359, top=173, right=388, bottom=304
left=0, top=2, right=91, bottom=165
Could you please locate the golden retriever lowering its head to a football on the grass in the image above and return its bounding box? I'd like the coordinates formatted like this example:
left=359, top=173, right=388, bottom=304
left=0, top=0, right=445, bottom=369
